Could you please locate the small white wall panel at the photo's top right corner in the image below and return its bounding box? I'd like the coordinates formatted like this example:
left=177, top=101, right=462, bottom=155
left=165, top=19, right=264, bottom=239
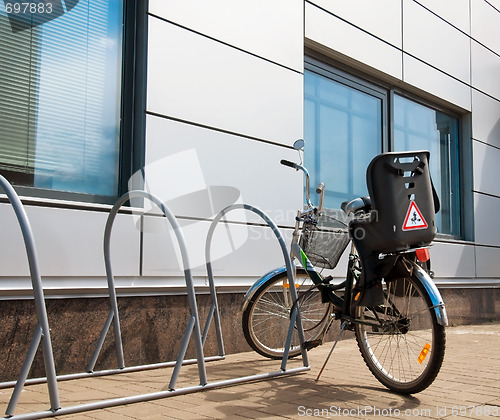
left=471, top=0, right=500, bottom=54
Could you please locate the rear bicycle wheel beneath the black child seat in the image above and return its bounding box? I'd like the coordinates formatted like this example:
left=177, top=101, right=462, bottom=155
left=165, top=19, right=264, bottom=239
left=354, top=275, right=446, bottom=394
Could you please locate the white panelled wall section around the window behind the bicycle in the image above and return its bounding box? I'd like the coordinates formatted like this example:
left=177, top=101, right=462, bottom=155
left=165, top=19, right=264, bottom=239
left=305, top=0, right=500, bottom=286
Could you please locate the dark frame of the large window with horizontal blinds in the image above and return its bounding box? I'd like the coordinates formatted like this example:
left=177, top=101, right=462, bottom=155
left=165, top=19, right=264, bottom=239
left=2, top=0, right=148, bottom=207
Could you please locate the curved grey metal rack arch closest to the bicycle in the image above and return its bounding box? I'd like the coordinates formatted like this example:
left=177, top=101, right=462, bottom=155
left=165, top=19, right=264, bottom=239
left=205, top=203, right=309, bottom=371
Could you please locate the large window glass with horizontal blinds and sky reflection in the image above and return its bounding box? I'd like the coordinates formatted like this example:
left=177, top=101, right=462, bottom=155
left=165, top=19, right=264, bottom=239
left=0, top=0, right=145, bottom=201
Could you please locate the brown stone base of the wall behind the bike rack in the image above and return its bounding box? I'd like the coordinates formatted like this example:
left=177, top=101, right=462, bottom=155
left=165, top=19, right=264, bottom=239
left=0, top=288, right=500, bottom=381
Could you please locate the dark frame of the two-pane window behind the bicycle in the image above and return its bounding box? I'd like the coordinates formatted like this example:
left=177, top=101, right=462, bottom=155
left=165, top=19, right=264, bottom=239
left=304, top=51, right=474, bottom=242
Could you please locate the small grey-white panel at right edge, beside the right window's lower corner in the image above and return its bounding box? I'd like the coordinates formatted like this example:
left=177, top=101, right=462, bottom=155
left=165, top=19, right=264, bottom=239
left=474, top=194, right=500, bottom=246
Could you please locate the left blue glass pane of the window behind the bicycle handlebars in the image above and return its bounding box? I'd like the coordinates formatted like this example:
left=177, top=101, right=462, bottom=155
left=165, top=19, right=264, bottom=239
left=304, top=70, right=385, bottom=208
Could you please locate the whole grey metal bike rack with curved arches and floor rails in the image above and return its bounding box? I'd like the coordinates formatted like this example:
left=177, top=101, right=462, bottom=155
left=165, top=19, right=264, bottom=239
left=0, top=185, right=310, bottom=419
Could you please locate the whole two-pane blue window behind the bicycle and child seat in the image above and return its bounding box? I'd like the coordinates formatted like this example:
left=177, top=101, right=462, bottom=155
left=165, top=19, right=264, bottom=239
left=304, top=59, right=462, bottom=237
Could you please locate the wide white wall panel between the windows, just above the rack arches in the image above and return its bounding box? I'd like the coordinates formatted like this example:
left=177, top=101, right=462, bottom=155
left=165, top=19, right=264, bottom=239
left=146, top=116, right=303, bottom=225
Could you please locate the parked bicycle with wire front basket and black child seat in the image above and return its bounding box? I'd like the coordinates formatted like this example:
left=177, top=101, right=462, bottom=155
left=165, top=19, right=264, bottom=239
left=242, top=141, right=447, bottom=394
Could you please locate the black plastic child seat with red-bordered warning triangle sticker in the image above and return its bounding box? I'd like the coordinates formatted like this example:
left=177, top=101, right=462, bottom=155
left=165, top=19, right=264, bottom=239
left=349, top=151, right=439, bottom=306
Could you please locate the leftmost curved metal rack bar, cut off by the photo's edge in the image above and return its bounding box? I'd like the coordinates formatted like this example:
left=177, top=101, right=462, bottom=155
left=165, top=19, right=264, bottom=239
left=0, top=175, right=61, bottom=415
